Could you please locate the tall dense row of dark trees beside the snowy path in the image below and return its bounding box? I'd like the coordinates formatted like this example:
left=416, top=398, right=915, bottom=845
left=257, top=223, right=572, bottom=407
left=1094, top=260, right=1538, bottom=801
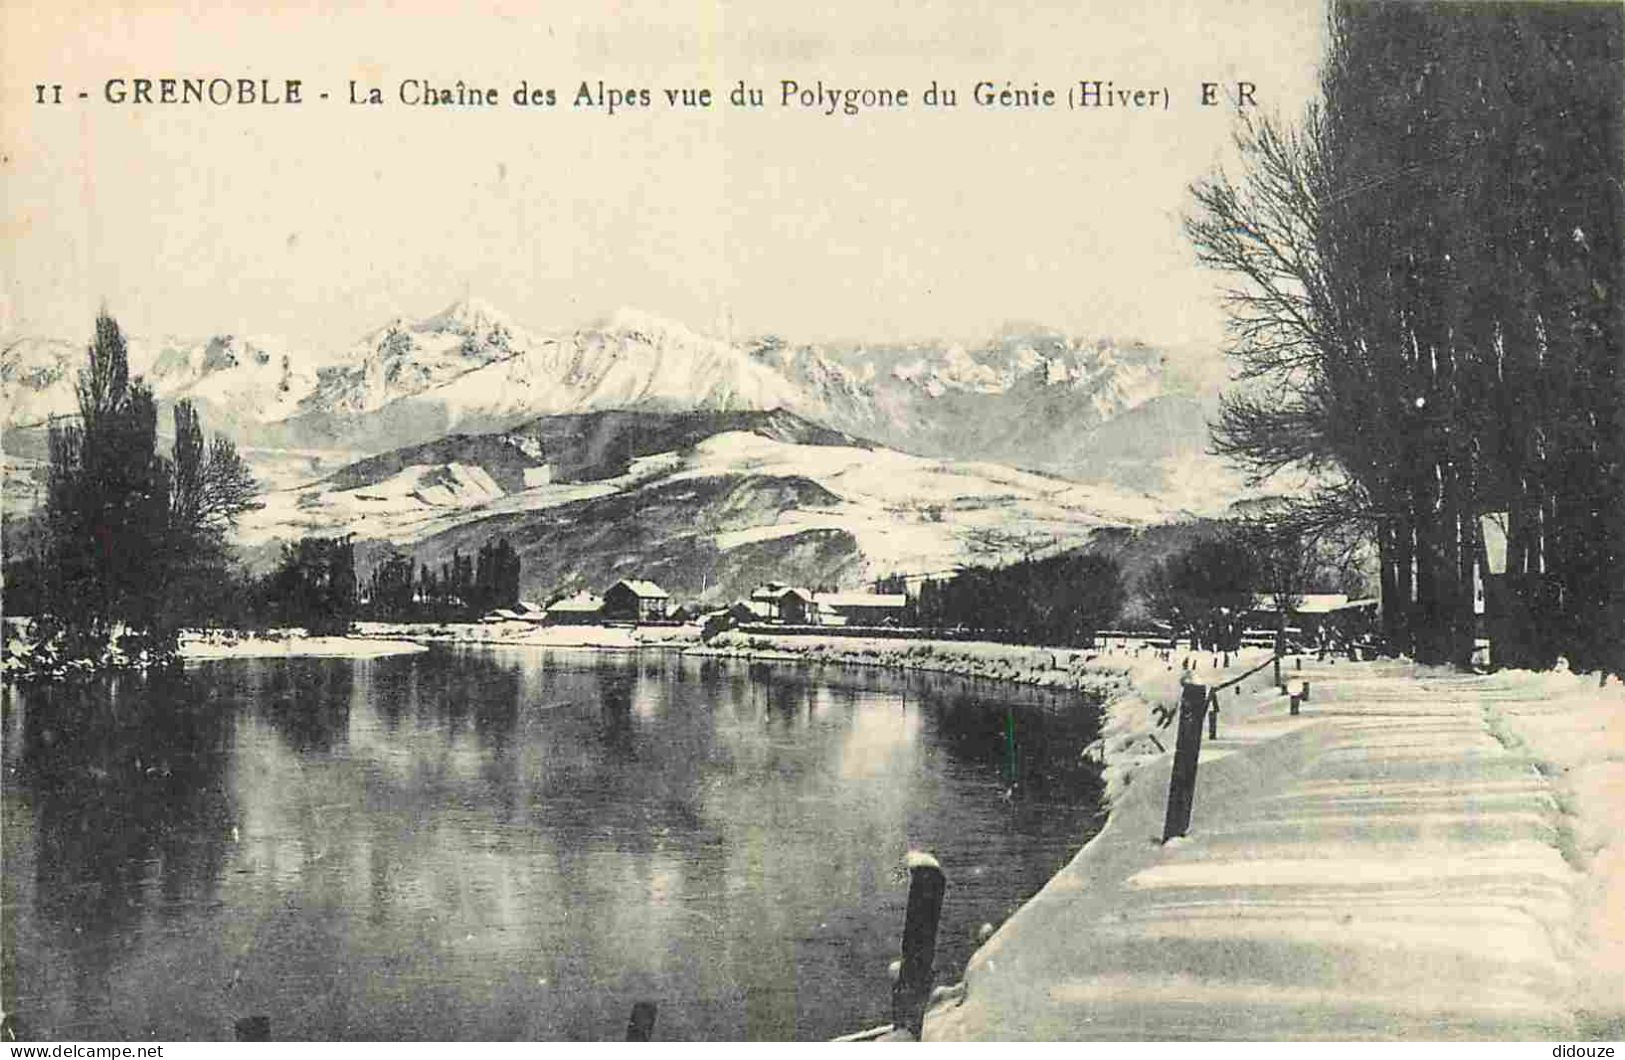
left=1186, top=3, right=1625, bottom=673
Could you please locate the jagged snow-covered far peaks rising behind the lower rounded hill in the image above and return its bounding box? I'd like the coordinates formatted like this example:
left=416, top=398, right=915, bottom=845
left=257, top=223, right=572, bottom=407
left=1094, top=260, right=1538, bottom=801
left=0, top=299, right=1212, bottom=489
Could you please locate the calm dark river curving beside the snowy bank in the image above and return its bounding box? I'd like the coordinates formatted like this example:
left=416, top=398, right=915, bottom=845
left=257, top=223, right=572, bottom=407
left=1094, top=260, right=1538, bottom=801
left=0, top=649, right=1100, bottom=1040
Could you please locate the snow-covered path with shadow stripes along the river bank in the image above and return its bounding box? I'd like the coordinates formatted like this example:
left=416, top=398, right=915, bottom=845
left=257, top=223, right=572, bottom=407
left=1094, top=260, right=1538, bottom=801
left=926, top=662, right=1625, bottom=1040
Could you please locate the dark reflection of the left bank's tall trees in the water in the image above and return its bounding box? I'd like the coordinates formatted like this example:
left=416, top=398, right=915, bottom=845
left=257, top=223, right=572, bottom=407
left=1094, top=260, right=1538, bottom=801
left=3, top=675, right=236, bottom=1037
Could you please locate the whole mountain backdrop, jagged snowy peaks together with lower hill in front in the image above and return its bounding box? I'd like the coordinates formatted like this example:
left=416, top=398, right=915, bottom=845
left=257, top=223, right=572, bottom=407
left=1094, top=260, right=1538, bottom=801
left=0, top=299, right=1240, bottom=593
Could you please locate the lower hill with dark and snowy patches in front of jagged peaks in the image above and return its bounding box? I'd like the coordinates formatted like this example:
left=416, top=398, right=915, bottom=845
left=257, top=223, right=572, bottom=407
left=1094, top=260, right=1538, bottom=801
left=239, top=411, right=1168, bottom=597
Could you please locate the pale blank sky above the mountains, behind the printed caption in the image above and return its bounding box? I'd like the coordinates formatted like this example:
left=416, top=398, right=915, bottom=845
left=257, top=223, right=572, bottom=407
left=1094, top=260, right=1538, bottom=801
left=0, top=0, right=1324, bottom=356
